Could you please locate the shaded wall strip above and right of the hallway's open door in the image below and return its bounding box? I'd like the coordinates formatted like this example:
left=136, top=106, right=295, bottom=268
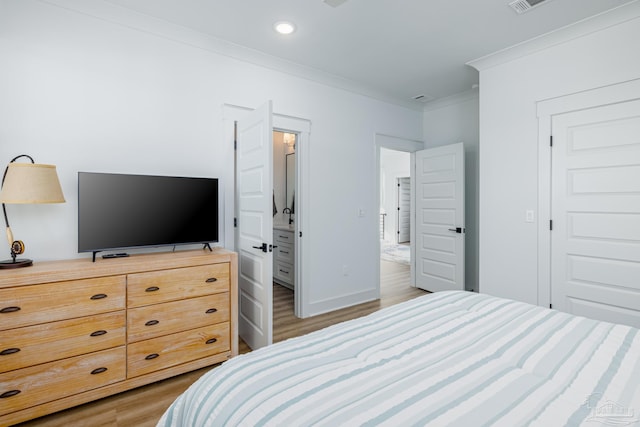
left=423, top=95, right=479, bottom=291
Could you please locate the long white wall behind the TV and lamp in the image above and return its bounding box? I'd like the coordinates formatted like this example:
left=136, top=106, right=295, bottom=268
left=0, top=0, right=422, bottom=318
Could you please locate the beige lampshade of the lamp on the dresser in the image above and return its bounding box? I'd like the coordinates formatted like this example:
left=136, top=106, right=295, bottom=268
left=0, top=163, right=65, bottom=204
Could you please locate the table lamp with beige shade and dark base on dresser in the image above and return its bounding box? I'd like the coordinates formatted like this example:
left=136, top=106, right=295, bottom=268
left=0, top=154, right=65, bottom=269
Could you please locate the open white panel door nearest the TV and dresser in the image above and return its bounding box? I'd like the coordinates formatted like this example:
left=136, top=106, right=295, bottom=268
left=236, top=101, right=273, bottom=350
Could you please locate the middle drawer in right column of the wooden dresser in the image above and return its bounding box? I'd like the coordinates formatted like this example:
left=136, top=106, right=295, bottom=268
left=127, top=292, right=229, bottom=343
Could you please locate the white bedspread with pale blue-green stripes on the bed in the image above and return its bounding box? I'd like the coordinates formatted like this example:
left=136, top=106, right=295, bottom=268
left=158, top=292, right=640, bottom=427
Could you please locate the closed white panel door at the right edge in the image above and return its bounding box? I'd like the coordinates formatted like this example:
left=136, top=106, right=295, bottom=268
left=551, top=100, right=640, bottom=327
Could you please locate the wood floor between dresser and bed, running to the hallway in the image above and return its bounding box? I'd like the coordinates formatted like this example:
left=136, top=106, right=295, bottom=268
left=20, top=260, right=425, bottom=427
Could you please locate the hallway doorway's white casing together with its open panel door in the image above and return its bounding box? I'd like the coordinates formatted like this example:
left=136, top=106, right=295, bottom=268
left=376, top=134, right=465, bottom=293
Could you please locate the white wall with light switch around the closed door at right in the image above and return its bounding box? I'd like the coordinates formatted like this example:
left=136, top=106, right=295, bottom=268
left=474, top=3, right=640, bottom=304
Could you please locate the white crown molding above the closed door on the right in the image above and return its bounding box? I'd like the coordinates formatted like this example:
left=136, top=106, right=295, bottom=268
left=467, top=0, right=640, bottom=71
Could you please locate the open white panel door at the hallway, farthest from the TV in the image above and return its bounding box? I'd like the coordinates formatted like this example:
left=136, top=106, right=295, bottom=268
left=413, top=143, right=465, bottom=292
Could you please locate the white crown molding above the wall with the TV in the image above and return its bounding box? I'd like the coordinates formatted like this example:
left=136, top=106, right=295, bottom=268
left=38, top=0, right=422, bottom=111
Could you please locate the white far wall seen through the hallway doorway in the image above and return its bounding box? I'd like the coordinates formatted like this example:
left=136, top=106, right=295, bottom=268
left=380, top=148, right=411, bottom=243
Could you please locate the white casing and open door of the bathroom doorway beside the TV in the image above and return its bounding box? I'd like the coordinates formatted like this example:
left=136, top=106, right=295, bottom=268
left=228, top=101, right=311, bottom=349
